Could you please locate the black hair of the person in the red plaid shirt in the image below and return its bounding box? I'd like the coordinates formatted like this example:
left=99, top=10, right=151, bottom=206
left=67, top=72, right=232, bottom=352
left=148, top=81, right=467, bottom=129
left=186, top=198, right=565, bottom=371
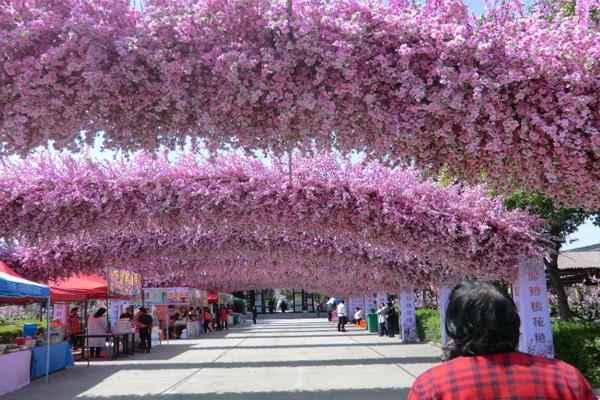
left=445, top=281, right=521, bottom=358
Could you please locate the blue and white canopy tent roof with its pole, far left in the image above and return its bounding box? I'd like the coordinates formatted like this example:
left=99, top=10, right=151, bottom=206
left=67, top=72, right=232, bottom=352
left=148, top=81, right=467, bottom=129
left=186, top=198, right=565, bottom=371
left=0, top=261, right=50, bottom=383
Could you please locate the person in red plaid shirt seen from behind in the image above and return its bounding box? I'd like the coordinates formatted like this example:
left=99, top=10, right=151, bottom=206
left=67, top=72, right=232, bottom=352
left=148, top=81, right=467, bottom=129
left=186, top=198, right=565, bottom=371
left=408, top=281, right=596, bottom=400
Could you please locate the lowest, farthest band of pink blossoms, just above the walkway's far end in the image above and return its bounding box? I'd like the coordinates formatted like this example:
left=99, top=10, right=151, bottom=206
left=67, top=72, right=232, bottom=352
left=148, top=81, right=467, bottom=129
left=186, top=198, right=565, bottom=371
left=13, top=228, right=474, bottom=287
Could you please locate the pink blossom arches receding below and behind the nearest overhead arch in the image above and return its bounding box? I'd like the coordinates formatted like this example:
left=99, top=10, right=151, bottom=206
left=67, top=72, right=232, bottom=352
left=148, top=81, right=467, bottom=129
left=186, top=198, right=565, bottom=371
left=0, top=153, right=541, bottom=292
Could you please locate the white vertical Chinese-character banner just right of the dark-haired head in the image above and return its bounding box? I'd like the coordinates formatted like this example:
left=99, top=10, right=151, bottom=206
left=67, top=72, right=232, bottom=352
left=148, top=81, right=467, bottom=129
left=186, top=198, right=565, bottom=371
left=513, top=258, right=554, bottom=358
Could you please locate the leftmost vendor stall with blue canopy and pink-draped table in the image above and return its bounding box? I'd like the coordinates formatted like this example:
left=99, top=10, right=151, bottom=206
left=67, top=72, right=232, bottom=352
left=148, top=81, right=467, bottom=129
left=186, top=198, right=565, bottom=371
left=0, top=262, right=54, bottom=395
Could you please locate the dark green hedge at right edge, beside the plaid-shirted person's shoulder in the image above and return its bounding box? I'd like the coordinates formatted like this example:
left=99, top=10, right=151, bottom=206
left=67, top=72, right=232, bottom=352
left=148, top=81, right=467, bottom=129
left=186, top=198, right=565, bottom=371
left=552, top=321, right=600, bottom=385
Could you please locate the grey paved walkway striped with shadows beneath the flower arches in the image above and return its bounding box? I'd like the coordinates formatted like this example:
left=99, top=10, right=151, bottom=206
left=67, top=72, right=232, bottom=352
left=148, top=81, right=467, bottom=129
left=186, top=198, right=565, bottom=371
left=2, top=318, right=440, bottom=400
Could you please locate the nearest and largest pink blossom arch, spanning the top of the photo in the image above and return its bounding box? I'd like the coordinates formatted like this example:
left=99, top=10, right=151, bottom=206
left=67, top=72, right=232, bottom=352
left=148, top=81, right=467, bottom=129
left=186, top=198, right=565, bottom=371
left=0, top=0, right=600, bottom=207
